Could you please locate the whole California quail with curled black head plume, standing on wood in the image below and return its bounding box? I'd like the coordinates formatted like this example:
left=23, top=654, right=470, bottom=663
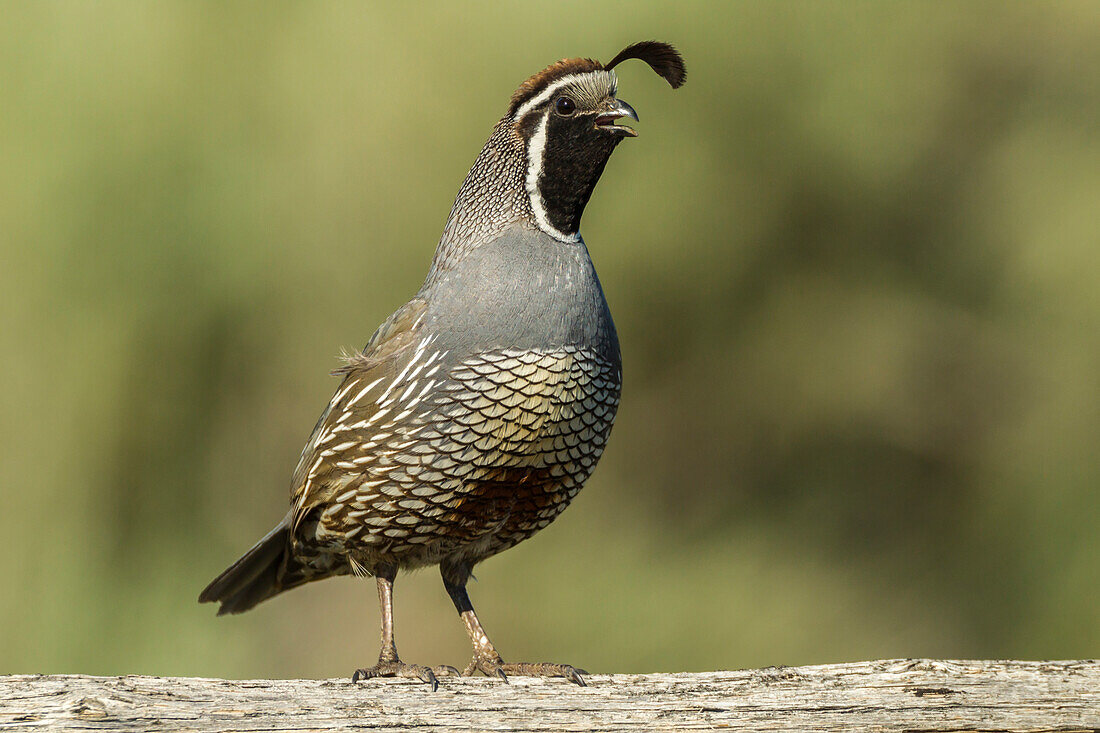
left=199, top=41, right=685, bottom=689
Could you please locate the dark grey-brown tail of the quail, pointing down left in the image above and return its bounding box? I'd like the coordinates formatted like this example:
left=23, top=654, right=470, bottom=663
left=199, top=516, right=298, bottom=616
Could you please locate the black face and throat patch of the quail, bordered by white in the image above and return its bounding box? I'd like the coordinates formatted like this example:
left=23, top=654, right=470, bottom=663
left=538, top=112, right=623, bottom=234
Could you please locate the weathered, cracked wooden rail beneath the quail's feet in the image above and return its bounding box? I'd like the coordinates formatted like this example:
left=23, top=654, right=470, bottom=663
left=0, top=659, right=1100, bottom=732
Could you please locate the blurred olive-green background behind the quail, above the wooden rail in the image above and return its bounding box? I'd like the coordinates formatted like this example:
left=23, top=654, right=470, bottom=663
left=0, top=1, right=1100, bottom=677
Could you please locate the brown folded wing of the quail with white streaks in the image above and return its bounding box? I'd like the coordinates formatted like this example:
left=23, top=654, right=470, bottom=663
left=290, top=298, right=428, bottom=533
